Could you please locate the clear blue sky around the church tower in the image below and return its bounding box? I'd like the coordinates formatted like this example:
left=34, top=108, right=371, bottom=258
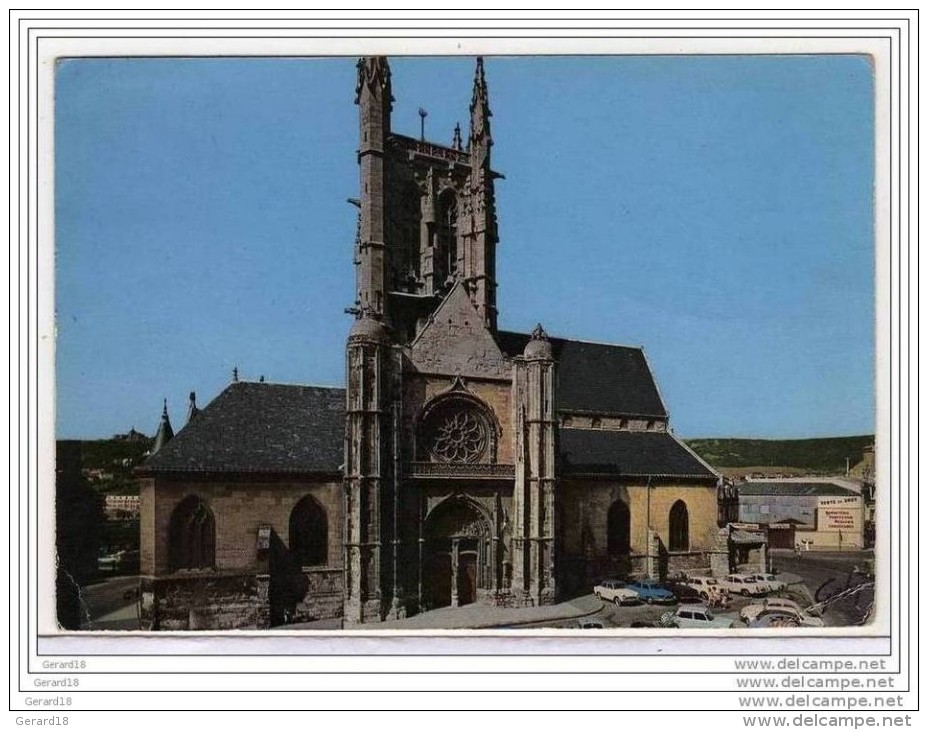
left=55, top=56, right=874, bottom=438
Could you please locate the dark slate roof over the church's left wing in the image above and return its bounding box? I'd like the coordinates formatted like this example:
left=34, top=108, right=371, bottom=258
left=139, top=383, right=345, bottom=473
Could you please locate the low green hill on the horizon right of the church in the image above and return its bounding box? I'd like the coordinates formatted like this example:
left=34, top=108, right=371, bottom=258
left=686, top=435, right=873, bottom=474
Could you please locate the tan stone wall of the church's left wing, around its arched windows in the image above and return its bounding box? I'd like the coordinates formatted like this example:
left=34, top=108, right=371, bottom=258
left=141, top=477, right=344, bottom=630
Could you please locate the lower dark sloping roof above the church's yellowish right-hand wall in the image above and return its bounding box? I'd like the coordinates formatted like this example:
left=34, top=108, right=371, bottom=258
left=559, top=428, right=716, bottom=479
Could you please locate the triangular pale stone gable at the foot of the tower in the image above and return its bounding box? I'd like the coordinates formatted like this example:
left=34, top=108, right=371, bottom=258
left=409, top=282, right=511, bottom=379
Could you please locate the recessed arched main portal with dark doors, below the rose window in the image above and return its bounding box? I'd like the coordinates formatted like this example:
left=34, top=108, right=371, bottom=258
left=421, top=497, right=493, bottom=610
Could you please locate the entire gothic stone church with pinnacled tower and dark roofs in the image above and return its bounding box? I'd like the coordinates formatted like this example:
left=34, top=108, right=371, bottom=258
left=139, top=57, right=719, bottom=630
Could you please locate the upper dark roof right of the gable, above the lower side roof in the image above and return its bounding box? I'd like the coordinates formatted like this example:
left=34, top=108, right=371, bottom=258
left=496, top=332, right=667, bottom=418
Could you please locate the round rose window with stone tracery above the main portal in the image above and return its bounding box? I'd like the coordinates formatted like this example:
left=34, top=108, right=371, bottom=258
left=423, top=401, right=490, bottom=463
